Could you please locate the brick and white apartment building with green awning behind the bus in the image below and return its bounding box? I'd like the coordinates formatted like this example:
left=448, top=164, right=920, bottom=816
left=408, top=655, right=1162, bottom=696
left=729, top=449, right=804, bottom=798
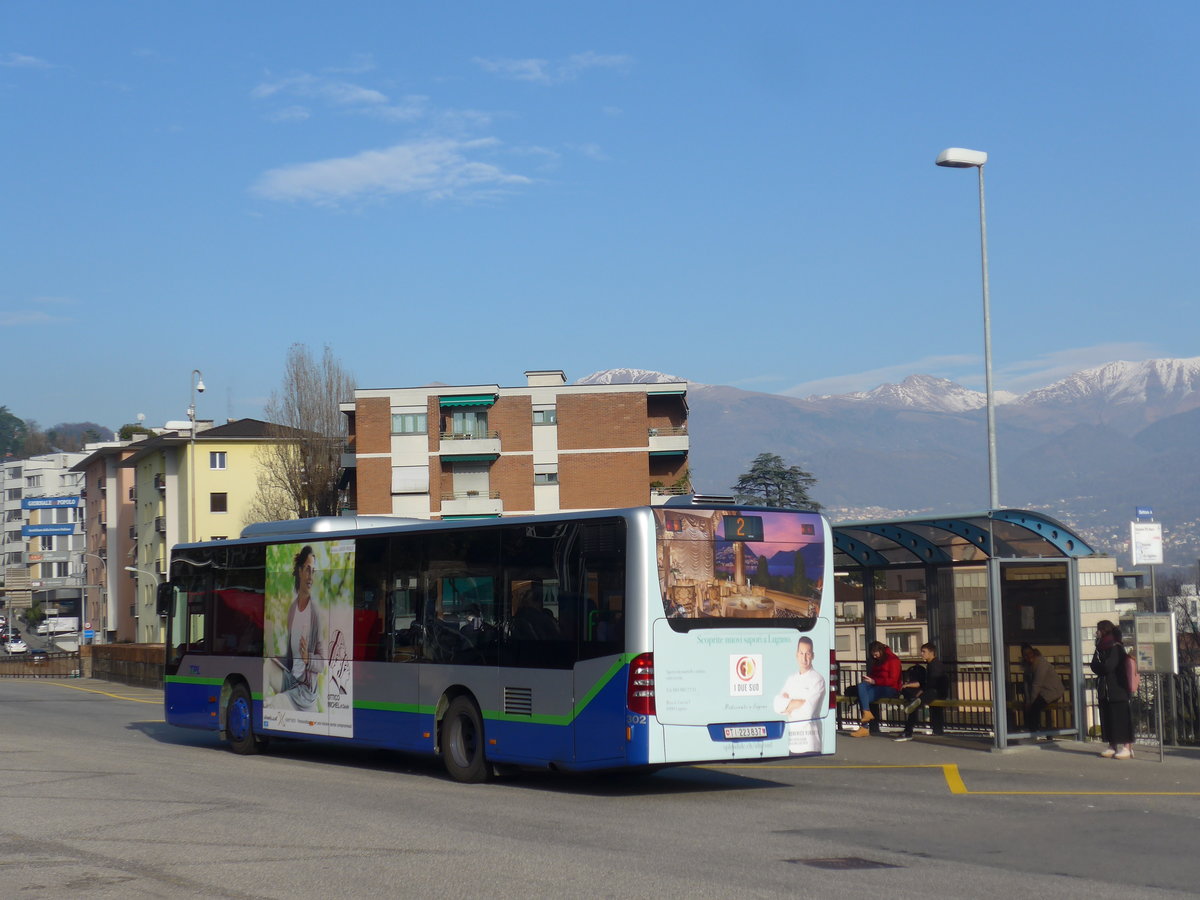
left=342, top=370, right=689, bottom=518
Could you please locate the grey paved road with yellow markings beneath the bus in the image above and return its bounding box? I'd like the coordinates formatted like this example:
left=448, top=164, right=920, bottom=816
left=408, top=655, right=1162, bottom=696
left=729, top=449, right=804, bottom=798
left=0, top=679, right=1200, bottom=900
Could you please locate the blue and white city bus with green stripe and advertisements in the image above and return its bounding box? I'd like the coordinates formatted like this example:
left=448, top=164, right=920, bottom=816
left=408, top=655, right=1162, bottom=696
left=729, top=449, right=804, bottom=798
left=161, top=498, right=835, bottom=782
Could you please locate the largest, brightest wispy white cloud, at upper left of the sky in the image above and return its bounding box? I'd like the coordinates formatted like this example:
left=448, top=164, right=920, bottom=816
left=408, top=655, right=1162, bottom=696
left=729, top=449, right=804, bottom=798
left=251, top=138, right=532, bottom=205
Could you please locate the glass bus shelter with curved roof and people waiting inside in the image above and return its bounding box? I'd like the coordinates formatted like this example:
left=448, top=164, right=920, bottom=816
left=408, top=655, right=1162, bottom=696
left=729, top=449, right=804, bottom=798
left=833, top=509, right=1094, bottom=749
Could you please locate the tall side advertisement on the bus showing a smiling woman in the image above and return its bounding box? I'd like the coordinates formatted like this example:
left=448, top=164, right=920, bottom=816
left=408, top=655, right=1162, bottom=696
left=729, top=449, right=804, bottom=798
left=263, top=541, right=354, bottom=738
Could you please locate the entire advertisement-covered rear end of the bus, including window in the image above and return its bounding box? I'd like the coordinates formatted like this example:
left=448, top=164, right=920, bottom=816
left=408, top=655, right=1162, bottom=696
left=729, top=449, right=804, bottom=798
left=654, top=508, right=834, bottom=760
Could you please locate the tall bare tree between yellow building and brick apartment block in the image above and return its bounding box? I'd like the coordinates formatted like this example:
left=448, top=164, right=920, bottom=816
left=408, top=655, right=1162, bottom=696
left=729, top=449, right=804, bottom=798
left=248, top=343, right=354, bottom=521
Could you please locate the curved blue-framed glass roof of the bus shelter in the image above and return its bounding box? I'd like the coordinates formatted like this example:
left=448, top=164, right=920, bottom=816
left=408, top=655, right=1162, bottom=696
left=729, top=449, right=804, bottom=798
left=832, top=509, right=1096, bottom=569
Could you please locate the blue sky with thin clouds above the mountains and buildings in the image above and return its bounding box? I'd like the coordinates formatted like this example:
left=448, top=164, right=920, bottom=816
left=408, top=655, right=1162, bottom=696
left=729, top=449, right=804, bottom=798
left=0, top=0, right=1200, bottom=427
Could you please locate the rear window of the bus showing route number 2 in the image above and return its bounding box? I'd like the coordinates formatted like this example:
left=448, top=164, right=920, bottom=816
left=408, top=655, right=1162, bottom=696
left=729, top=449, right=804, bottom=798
left=654, top=508, right=826, bottom=628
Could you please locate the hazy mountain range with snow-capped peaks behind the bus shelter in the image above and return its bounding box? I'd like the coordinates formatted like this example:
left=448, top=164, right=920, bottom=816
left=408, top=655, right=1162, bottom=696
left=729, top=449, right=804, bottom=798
left=580, top=358, right=1200, bottom=564
